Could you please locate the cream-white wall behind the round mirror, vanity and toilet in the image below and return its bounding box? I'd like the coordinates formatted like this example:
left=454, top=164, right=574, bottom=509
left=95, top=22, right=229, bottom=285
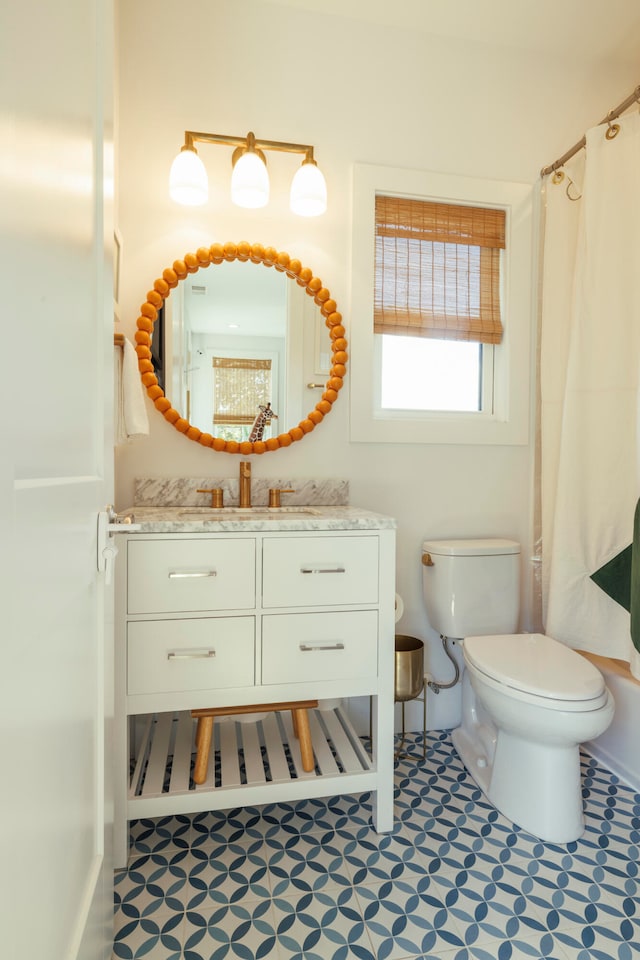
left=116, top=0, right=638, bottom=727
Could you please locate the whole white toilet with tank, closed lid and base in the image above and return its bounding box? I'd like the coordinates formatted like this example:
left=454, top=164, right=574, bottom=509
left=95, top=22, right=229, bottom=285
left=422, top=539, right=615, bottom=844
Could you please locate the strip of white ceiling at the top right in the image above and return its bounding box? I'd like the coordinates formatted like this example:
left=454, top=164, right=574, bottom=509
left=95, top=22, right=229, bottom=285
left=270, top=0, right=640, bottom=62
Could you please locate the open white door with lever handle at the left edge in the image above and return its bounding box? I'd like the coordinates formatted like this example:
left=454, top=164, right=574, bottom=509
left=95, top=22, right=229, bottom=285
left=0, top=0, right=113, bottom=960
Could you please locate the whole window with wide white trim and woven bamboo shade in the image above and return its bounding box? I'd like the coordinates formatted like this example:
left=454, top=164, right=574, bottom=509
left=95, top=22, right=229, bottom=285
left=351, top=165, right=532, bottom=443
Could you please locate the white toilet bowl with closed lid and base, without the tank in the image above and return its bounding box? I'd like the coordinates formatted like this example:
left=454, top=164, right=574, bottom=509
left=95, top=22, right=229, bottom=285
left=452, top=634, right=614, bottom=843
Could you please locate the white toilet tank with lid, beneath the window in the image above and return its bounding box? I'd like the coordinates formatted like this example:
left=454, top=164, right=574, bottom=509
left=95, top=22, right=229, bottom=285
left=422, top=539, right=520, bottom=637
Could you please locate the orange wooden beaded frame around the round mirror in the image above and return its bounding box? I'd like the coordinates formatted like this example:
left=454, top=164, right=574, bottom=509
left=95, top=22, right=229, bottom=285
left=135, top=241, right=347, bottom=456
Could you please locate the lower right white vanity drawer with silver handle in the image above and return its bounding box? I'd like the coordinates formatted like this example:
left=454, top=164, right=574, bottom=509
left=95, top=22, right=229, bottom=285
left=262, top=610, right=378, bottom=684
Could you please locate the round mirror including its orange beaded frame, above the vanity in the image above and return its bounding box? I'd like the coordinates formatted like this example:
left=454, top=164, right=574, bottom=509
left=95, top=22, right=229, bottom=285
left=135, top=241, right=347, bottom=456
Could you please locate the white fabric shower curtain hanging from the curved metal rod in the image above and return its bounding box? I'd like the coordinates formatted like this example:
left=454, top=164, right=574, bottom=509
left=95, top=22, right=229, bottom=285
left=540, top=112, right=640, bottom=678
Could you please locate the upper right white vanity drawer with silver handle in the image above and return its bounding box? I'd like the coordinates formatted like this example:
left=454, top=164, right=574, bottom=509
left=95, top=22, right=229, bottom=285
left=262, top=536, right=379, bottom=607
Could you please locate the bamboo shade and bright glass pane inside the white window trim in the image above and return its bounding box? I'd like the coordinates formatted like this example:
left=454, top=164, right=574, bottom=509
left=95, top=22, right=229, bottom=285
left=373, top=195, right=505, bottom=413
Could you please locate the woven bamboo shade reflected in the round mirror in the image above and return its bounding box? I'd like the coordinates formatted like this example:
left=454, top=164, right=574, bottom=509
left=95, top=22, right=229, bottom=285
left=213, top=357, right=271, bottom=426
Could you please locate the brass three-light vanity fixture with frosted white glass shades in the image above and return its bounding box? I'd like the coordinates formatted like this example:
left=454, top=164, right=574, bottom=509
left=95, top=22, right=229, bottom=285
left=169, top=130, right=327, bottom=217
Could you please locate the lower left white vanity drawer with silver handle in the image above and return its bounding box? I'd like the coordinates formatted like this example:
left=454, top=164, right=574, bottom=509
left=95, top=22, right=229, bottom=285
left=127, top=617, right=255, bottom=696
